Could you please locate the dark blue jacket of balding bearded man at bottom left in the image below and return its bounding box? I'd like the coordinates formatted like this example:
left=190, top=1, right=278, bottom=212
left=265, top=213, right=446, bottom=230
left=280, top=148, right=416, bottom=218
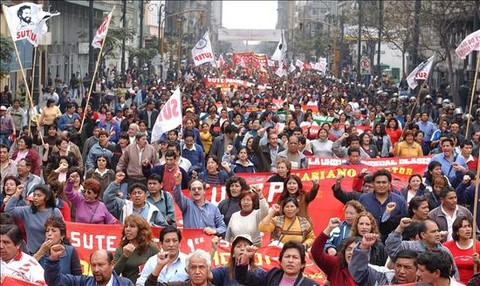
left=44, top=259, right=134, bottom=286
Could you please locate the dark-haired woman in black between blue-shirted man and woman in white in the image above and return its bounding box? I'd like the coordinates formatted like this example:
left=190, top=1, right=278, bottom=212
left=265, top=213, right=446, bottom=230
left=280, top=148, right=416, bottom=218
left=218, top=176, right=250, bottom=225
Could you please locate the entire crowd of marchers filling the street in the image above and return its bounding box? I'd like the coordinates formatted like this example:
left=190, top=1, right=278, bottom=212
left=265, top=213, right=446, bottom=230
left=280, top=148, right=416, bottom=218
left=0, top=58, right=480, bottom=286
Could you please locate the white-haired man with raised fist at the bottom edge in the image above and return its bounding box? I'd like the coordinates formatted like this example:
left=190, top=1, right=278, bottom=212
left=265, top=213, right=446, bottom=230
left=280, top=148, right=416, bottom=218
left=145, top=249, right=213, bottom=286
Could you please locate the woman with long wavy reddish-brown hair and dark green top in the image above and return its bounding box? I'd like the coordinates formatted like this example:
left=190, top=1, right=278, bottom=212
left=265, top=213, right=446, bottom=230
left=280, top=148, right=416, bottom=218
left=113, top=214, right=159, bottom=283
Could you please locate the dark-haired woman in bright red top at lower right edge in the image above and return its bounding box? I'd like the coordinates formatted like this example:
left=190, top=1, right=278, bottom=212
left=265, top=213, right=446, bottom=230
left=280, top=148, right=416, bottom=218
left=443, top=216, right=480, bottom=284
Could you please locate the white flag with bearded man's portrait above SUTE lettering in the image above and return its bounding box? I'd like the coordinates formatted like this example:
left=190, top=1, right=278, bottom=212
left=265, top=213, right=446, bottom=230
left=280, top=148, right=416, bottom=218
left=3, top=2, right=60, bottom=47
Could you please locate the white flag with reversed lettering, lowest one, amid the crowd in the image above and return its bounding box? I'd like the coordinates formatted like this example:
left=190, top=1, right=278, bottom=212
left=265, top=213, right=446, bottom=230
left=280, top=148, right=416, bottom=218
left=152, top=87, right=182, bottom=142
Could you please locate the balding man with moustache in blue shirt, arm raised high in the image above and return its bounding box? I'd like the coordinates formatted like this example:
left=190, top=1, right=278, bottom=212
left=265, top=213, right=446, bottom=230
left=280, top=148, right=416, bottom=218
left=173, top=171, right=227, bottom=236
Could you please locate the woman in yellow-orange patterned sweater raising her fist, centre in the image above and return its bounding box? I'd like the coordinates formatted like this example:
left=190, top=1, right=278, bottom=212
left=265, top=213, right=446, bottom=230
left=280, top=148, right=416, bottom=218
left=258, top=197, right=315, bottom=249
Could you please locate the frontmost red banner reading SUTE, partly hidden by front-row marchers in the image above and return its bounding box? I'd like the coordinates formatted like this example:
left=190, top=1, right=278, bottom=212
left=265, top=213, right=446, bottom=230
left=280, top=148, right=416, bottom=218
left=66, top=222, right=325, bottom=285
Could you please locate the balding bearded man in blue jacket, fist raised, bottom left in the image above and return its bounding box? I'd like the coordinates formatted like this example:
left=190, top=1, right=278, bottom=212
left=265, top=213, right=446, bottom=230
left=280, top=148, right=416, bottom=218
left=45, top=247, right=133, bottom=286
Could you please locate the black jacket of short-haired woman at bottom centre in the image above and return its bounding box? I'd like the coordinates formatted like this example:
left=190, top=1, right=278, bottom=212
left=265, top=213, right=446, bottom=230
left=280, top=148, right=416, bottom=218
left=235, top=265, right=318, bottom=286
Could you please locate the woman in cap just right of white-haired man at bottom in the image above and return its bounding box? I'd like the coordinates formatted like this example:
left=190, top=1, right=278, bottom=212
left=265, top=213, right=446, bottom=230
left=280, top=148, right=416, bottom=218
left=209, top=234, right=265, bottom=285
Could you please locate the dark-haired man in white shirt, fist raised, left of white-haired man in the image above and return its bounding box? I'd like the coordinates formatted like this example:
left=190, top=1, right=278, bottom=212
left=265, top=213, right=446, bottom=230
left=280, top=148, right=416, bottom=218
left=136, top=226, right=188, bottom=286
